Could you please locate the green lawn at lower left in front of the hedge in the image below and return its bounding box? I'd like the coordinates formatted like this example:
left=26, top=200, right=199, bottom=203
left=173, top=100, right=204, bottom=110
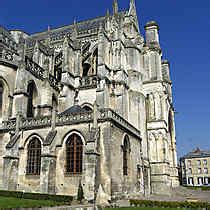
left=0, top=196, right=62, bottom=208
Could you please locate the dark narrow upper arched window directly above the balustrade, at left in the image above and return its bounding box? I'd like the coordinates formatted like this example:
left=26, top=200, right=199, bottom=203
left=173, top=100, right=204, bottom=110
left=27, top=81, right=35, bottom=117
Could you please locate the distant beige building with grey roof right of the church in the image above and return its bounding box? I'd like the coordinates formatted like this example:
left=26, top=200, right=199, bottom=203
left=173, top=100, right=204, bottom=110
left=180, top=148, right=210, bottom=186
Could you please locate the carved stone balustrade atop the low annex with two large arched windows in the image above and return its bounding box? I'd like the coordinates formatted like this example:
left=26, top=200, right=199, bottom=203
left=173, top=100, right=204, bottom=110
left=0, top=109, right=140, bottom=138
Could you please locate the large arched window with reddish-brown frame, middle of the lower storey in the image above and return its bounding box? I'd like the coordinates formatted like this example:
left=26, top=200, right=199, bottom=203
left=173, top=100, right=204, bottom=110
left=66, top=134, right=83, bottom=174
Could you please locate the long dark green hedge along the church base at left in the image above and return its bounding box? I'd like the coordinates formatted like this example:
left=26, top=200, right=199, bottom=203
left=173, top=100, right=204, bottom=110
left=0, top=190, right=73, bottom=203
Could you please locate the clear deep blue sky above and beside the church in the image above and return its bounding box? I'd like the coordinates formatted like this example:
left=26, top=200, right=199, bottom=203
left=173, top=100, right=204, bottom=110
left=0, top=0, right=210, bottom=158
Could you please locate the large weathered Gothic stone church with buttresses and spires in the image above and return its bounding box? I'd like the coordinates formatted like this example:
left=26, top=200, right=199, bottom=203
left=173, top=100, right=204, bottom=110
left=0, top=0, right=179, bottom=201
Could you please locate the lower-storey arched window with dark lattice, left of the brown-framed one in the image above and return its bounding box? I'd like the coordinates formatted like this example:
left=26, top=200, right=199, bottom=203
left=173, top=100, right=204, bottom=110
left=26, top=138, right=41, bottom=175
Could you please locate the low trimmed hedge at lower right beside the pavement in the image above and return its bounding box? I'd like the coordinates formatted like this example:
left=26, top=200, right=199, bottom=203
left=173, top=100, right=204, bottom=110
left=130, top=199, right=210, bottom=210
